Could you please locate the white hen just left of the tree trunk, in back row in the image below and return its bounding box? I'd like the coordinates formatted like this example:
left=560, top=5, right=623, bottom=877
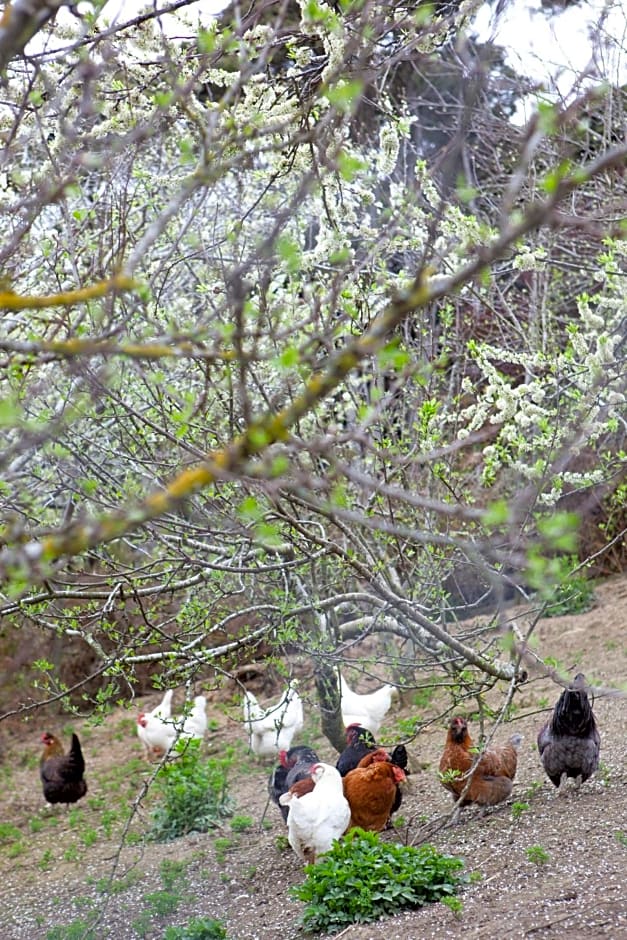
left=244, top=681, right=304, bottom=757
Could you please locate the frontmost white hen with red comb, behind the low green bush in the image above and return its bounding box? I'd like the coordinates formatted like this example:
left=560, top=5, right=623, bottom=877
left=279, top=764, right=351, bottom=864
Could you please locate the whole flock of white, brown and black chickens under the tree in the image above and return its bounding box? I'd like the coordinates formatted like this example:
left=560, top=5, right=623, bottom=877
left=40, top=673, right=601, bottom=863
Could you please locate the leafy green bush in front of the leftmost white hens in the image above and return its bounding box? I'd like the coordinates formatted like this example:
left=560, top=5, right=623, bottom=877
left=148, top=741, right=231, bottom=842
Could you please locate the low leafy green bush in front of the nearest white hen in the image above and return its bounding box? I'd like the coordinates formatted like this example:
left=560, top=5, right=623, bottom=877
left=291, top=829, right=466, bottom=932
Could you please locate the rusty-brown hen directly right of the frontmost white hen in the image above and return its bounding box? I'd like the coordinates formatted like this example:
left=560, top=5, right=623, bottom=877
left=344, top=748, right=406, bottom=832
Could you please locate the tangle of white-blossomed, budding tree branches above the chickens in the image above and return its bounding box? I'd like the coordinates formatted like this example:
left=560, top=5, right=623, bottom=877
left=0, top=0, right=627, bottom=736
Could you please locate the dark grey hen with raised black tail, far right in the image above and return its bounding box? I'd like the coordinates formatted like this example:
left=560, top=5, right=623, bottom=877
left=538, top=673, right=601, bottom=793
